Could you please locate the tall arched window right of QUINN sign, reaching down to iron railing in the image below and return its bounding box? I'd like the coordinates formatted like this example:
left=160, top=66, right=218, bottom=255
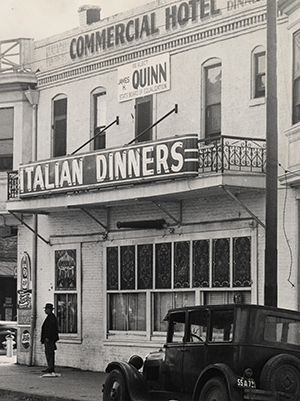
left=204, top=58, right=222, bottom=138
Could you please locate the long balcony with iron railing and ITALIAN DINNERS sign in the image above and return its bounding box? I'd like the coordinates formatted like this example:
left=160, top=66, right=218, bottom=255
left=7, top=134, right=266, bottom=212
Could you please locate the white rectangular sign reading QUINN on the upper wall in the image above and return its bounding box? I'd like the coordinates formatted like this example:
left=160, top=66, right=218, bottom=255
left=118, top=53, right=170, bottom=102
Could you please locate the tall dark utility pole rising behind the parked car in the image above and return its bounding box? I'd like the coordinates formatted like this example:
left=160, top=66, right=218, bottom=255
left=265, top=0, right=278, bottom=306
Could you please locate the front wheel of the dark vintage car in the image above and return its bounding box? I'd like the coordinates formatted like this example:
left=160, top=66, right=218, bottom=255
left=103, top=369, right=130, bottom=401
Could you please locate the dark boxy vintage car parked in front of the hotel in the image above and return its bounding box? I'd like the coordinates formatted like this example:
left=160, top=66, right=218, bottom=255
left=103, top=304, right=300, bottom=401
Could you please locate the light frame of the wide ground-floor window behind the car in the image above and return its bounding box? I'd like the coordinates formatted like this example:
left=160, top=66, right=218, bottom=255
left=104, top=228, right=257, bottom=342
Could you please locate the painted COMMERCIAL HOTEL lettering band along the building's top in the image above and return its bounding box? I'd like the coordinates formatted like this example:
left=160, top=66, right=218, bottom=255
left=69, top=0, right=265, bottom=61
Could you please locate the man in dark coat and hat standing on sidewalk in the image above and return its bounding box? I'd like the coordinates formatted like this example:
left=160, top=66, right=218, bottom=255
left=41, top=304, right=59, bottom=375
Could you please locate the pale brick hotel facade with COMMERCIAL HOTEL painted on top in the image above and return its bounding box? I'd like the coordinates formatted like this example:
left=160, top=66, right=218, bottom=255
left=0, top=0, right=300, bottom=370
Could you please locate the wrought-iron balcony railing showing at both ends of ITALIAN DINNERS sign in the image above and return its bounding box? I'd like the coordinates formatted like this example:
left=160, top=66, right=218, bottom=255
left=7, top=136, right=266, bottom=199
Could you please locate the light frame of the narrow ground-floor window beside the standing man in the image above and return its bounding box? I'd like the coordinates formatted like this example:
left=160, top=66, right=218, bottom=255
left=52, top=243, right=82, bottom=343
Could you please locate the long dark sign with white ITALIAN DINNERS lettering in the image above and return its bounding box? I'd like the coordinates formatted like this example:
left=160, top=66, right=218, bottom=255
left=19, top=134, right=198, bottom=198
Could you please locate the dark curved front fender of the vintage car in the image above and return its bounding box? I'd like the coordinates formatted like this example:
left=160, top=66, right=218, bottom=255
left=105, top=361, right=150, bottom=401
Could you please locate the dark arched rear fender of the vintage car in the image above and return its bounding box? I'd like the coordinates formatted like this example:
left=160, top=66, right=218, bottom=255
left=193, top=363, right=243, bottom=401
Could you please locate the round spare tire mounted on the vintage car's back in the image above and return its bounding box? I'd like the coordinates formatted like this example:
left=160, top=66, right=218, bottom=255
left=260, top=354, right=300, bottom=394
